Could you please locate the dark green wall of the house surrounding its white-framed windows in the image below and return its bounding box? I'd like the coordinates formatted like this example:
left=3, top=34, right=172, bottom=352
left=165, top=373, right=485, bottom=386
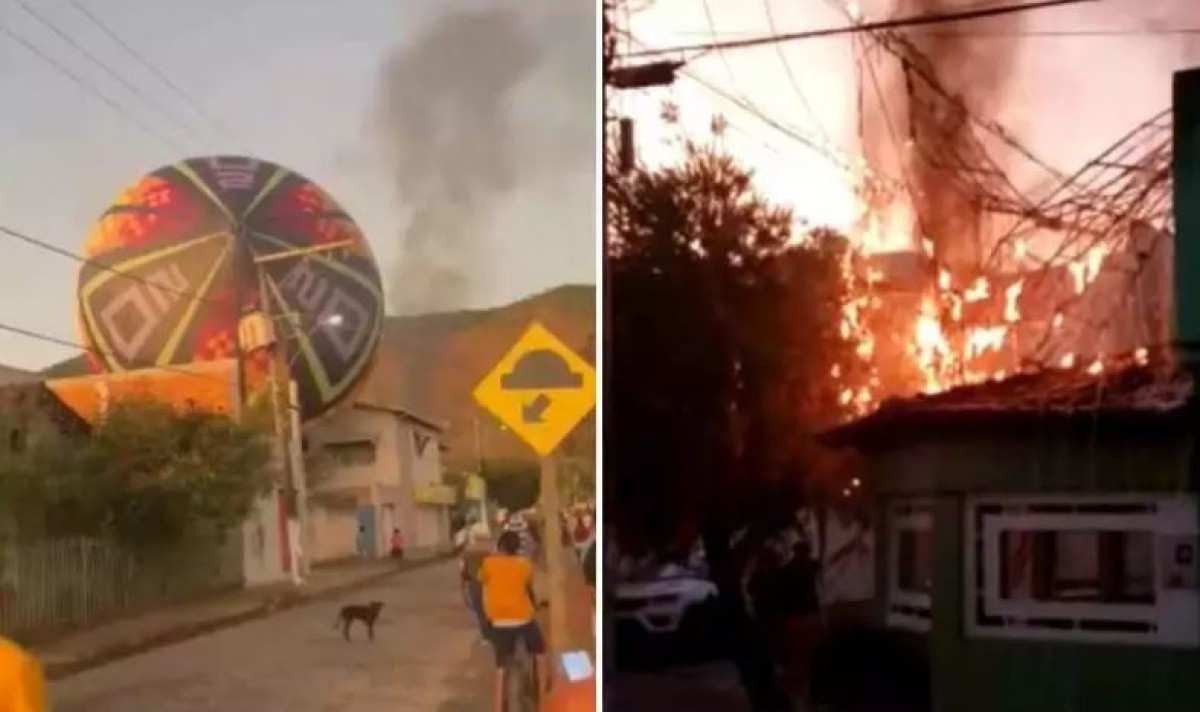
left=869, top=423, right=1200, bottom=712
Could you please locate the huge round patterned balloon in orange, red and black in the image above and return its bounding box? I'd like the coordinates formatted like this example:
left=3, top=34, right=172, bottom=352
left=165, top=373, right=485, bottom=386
left=78, top=156, right=384, bottom=420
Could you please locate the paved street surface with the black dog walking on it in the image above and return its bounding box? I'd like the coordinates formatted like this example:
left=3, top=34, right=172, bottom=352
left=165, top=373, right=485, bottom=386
left=50, top=562, right=491, bottom=712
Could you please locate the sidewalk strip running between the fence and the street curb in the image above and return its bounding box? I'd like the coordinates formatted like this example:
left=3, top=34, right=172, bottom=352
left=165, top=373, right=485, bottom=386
left=34, top=549, right=444, bottom=680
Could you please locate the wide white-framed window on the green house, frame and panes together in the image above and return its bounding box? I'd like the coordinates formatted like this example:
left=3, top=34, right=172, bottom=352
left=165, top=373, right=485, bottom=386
left=966, top=495, right=1200, bottom=647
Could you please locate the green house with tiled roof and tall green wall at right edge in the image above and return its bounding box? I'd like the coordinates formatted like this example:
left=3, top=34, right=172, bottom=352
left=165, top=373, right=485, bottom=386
left=827, top=70, right=1200, bottom=712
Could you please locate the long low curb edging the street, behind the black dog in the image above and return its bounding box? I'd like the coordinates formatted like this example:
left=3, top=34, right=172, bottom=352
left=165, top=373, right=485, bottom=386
left=43, top=555, right=452, bottom=681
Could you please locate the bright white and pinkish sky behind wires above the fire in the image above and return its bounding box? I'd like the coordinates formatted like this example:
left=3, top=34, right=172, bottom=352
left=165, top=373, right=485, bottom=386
left=612, top=0, right=1200, bottom=241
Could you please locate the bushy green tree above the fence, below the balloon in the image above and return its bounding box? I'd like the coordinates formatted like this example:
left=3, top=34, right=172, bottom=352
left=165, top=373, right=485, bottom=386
left=0, top=402, right=270, bottom=550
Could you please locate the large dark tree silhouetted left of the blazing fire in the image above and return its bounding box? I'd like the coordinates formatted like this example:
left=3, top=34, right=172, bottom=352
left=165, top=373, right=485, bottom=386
left=604, top=145, right=850, bottom=545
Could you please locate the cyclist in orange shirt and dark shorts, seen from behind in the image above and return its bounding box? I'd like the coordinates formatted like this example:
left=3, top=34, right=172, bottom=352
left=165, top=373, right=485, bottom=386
left=479, top=531, right=550, bottom=712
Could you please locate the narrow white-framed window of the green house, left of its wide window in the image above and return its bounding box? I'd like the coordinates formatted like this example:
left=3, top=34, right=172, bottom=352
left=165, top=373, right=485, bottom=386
left=888, top=501, right=934, bottom=630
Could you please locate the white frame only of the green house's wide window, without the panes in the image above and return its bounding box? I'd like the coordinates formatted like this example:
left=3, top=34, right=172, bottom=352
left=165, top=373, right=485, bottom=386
left=962, top=493, right=1200, bottom=647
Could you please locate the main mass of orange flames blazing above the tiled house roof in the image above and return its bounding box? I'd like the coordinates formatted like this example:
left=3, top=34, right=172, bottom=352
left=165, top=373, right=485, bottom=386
left=830, top=177, right=1128, bottom=415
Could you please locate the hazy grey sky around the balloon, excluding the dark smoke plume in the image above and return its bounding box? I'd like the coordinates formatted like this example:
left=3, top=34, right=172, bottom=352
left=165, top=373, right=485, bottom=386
left=0, top=0, right=596, bottom=369
